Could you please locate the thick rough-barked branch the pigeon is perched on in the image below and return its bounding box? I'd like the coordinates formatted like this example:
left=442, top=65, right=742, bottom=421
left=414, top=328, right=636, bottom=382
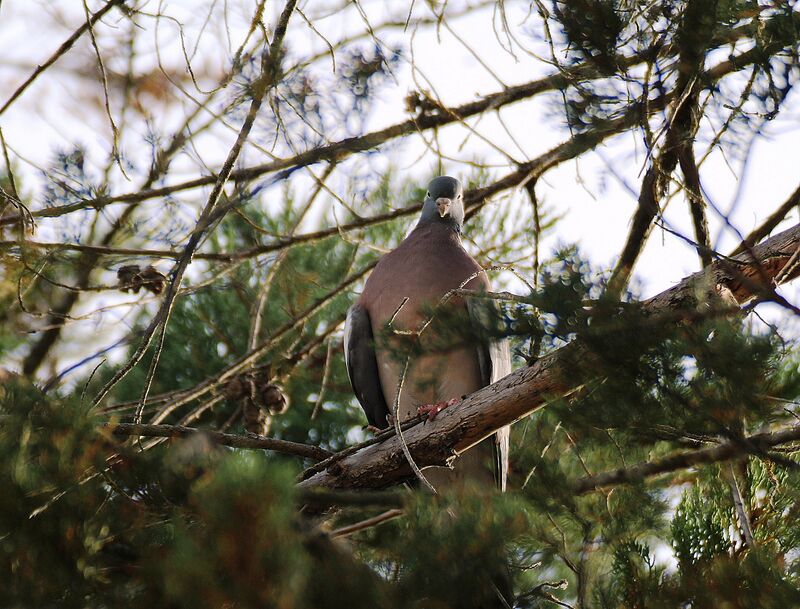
left=300, top=225, right=800, bottom=489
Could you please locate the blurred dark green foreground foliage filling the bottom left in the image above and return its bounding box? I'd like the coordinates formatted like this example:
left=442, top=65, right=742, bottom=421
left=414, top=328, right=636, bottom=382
left=0, top=384, right=536, bottom=609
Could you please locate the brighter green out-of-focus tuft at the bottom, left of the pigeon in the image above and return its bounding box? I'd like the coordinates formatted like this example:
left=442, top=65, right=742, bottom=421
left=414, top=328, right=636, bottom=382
left=145, top=455, right=311, bottom=609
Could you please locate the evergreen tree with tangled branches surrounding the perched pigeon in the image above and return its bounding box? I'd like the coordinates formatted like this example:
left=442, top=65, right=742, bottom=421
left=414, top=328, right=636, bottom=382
left=0, top=0, right=800, bottom=609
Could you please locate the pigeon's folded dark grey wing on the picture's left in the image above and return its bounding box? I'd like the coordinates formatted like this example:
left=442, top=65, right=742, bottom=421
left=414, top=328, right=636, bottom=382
left=344, top=304, right=389, bottom=429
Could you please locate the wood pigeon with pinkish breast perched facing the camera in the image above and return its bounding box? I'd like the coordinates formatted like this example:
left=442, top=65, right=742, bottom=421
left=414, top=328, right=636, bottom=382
left=344, top=176, right=511, bottom=490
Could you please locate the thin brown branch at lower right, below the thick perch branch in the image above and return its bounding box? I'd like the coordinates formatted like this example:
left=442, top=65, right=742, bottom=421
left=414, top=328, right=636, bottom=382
left=572, top=426, right=800, bottom=495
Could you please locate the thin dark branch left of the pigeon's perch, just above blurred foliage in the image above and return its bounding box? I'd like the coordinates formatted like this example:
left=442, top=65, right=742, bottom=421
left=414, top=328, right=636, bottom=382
left=100, top=423, right=331, bottom=461
